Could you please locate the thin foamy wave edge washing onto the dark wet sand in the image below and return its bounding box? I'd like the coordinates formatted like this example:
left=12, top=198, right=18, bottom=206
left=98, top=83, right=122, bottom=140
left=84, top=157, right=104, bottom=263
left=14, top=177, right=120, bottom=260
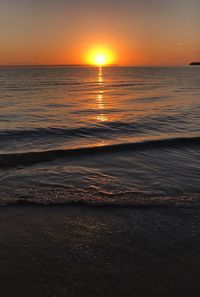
left=0, top=193, right=200, bottom=208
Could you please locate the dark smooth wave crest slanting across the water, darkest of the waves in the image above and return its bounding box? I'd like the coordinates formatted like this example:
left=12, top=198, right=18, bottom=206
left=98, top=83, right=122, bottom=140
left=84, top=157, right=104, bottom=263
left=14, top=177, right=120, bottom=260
left=0, top=137, right=200, bottom=167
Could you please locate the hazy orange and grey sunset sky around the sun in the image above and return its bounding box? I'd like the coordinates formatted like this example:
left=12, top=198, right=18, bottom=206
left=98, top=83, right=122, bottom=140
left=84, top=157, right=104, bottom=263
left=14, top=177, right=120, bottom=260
left=0, top=0, right=200, bottom=66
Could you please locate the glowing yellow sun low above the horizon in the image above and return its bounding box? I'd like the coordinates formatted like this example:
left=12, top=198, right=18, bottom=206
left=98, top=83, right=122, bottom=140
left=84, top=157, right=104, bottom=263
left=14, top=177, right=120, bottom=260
left=87, top=48, right=115, bottom=66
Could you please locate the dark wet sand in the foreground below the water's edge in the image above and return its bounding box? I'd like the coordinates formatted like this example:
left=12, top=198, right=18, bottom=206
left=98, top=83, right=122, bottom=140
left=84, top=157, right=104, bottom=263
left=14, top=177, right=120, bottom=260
left=0, top=205, right=200, bottom=297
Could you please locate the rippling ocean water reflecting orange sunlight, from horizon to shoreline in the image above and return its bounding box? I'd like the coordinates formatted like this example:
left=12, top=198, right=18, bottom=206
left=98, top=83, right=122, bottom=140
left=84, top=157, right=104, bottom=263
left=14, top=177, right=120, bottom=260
left=0, top=67, right=200, bottom=207
